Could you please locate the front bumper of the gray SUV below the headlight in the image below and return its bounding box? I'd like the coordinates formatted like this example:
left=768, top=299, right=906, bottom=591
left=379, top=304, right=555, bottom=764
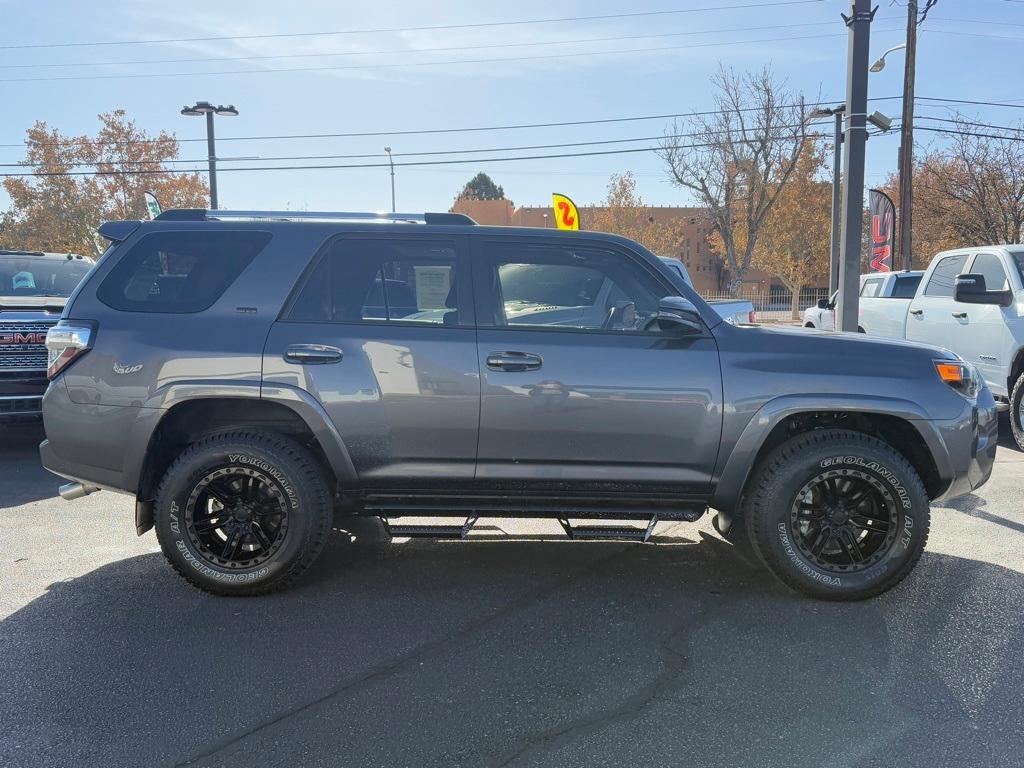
left=931, top=387, right=999, bottom=502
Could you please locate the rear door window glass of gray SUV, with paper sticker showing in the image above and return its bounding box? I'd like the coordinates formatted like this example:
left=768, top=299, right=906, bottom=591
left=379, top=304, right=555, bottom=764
left=288, top=239, right=462, bottom=325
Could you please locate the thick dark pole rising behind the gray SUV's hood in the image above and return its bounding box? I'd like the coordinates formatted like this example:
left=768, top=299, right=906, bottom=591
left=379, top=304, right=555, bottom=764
left=836, top=0, right=874, bottom=332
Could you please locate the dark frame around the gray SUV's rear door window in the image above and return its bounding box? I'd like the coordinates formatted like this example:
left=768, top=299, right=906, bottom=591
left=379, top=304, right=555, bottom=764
left=276, top=229, right=476, bottom=330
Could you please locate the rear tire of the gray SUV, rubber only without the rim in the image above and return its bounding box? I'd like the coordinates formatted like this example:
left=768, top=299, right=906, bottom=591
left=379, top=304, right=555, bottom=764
left=154, top=431, right=332, bottom=595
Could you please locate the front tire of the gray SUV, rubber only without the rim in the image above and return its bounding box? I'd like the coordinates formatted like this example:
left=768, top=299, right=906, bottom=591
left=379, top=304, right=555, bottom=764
left=742, top=429, right=929, bottom=600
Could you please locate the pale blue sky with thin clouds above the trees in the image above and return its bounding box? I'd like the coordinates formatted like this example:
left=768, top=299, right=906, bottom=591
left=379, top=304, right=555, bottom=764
left=0, top=0, right=1024, bottom=217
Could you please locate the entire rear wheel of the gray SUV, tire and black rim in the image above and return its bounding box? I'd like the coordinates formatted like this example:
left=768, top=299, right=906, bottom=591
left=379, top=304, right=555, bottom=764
left=154, top=431, right=332, bottom=595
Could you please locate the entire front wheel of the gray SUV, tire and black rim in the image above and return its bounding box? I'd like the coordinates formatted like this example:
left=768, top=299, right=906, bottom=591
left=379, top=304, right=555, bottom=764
left=743, top=429, right=929, bottom=600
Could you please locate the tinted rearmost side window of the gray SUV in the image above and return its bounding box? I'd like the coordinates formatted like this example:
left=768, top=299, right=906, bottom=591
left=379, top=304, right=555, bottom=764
left=96, top=231, right=270, bottom=312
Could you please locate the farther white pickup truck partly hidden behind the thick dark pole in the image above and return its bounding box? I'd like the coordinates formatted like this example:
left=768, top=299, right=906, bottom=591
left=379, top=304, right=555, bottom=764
left=804, top=270, right=924, bottom=331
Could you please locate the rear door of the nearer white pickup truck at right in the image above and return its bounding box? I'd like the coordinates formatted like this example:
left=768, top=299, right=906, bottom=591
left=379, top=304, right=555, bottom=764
left=906, top=253, right=973, bottom=357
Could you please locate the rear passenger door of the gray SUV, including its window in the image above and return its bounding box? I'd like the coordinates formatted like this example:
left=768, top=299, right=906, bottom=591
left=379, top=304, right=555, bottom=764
left=263, top=233, right=480, bottom=486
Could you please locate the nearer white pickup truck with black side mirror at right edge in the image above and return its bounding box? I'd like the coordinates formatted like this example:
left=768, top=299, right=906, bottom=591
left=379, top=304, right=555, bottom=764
left=860, top=246, right=1024, bottom=450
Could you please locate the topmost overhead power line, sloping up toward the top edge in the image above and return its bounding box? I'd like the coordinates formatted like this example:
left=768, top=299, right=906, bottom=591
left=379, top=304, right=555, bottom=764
left=0, top=0, right=824, bottom=50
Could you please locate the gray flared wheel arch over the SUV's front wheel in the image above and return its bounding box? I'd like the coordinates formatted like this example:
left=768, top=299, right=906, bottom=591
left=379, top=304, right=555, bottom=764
left=711, top=395, right=953, bottom=518
